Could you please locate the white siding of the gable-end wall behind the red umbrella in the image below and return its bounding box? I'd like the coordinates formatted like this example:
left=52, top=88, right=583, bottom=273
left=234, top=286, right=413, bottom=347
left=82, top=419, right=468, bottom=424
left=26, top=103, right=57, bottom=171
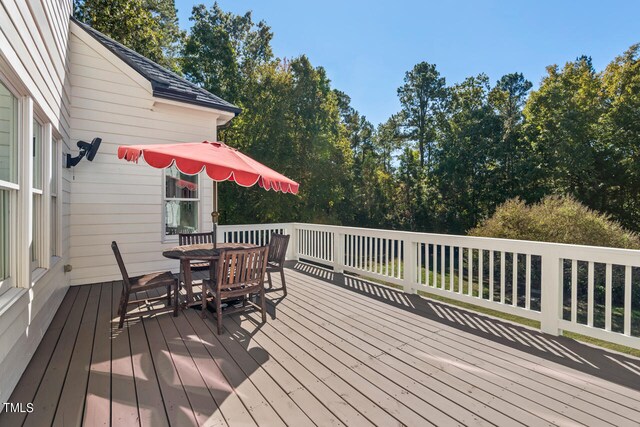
left=69, top=24, right=218, bottom=285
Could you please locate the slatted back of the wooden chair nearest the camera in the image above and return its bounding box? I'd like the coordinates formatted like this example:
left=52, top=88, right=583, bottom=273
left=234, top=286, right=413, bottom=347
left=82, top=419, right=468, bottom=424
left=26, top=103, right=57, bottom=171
left=216, top=246, right=269, bottom=292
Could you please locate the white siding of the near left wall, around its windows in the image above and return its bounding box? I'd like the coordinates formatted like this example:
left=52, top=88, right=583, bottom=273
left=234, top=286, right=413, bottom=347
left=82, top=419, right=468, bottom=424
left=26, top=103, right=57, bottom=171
left=0, top=0, right=72, bottom=403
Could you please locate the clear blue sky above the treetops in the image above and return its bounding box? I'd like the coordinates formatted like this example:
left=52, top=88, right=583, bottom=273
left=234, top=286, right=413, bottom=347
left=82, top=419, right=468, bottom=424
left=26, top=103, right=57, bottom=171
left=176, top=0, right=640, bottom=124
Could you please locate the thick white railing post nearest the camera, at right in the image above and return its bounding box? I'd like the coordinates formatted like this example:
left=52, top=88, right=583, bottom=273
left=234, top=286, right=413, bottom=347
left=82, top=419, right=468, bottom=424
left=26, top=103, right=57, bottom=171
left=540, top=253, right=562, bottom=336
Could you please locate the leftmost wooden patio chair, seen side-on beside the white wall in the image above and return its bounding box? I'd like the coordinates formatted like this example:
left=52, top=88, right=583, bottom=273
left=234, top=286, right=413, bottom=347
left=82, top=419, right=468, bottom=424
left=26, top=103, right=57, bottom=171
left=111, top=242, right=178, bottom=329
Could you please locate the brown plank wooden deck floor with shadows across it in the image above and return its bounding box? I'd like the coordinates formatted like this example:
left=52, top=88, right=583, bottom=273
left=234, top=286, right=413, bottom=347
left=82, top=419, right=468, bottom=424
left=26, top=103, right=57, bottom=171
left=0, top=263, right=640, bottom=427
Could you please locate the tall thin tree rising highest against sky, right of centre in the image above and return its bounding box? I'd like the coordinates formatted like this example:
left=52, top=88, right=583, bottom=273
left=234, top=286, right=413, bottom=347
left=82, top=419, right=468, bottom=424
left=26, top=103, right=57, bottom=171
left=398, top=62, right=446, bottom=168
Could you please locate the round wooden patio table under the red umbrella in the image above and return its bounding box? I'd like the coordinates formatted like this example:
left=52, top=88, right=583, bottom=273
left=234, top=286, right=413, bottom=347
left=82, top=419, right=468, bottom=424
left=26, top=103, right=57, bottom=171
left=162, top=243, right=257, bottom=307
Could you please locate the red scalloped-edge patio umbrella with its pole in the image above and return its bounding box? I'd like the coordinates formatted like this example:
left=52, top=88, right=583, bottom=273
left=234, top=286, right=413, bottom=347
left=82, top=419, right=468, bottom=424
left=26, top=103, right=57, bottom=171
left=118, top=141, right=299, bottom=224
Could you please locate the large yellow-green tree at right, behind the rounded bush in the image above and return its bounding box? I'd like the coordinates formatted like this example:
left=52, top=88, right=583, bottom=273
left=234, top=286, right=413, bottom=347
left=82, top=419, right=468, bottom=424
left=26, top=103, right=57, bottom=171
left=524, top=56, right=615, bottom=211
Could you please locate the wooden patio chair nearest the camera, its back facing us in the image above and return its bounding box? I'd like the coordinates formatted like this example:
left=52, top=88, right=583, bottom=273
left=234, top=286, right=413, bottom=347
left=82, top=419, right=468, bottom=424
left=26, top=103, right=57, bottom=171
left=202, top=246, right=269, bottom=335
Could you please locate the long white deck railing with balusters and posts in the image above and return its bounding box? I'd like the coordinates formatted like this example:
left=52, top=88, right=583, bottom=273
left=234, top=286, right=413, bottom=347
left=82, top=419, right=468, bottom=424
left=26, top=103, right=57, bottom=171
left=218, top=223, right=640, bottom=348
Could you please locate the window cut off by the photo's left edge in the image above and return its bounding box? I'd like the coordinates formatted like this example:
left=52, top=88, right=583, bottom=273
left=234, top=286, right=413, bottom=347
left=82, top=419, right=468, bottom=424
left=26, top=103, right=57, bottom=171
left=0, top=79, right=19, bottom=294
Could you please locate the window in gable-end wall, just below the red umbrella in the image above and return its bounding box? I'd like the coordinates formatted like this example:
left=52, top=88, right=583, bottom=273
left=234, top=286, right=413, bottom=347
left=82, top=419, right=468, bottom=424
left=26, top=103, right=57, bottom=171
left=164, top=166, right=200, bottom=236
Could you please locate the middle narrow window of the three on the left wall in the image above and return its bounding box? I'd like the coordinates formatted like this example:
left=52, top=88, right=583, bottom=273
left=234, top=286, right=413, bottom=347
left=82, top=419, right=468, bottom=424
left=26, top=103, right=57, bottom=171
left=31, top=120, right=43, bottom=270
